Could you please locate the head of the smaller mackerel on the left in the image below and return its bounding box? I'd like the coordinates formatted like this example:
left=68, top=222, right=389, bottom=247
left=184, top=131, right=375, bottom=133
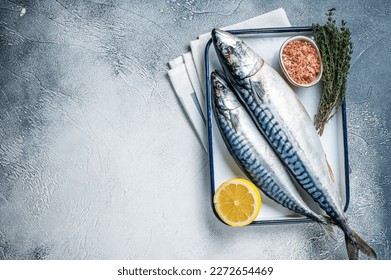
left=211, top=71, right=241, bottom=112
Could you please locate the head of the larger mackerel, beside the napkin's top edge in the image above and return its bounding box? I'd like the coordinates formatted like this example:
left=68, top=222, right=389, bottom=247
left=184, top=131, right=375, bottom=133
left=212, top=28, right=263, bottom=80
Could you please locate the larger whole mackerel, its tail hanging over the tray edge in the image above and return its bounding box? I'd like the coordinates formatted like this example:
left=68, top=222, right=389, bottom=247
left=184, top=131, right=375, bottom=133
left=212, top=29, right=376, bottom=259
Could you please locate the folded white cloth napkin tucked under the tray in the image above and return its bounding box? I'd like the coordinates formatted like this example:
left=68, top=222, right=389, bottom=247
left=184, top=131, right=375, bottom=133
left=168, top=8, right=291, bottom=150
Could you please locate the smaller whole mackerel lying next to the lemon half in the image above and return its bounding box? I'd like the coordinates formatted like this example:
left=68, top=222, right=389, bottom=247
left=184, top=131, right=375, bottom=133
left=212, top=72, right=327, bottom=224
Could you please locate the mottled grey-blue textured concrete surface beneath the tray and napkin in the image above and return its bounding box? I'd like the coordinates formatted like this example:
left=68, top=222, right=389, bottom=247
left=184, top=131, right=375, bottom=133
left=0, top=0, right=391, bottom=259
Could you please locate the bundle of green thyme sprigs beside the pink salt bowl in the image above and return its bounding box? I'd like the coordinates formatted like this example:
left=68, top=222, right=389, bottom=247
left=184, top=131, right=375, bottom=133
left=312, top=8, right=353, bottom=135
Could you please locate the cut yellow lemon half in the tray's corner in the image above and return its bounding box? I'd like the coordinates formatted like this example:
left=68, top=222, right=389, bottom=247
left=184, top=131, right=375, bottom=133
left=213, top=178, right=262, bottom=227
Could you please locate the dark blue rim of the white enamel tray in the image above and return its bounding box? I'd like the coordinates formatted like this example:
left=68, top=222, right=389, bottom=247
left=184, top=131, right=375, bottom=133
left=205, top=26, right=350, bottom=226
